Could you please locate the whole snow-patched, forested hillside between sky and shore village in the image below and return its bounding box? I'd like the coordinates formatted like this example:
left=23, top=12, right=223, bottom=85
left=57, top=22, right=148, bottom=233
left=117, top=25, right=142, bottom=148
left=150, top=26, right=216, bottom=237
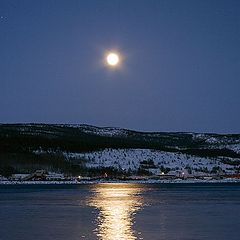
left=0, top=124, right=240, bottom=175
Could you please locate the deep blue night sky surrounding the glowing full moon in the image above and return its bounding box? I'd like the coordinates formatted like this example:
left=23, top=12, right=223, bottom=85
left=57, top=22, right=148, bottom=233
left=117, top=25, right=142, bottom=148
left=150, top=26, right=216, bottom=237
left=0, top=0, right=240, bottom=133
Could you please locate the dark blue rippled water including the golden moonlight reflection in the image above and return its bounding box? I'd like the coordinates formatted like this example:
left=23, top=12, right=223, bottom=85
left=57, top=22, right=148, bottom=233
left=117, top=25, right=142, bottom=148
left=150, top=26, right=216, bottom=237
left=0, top=183, right=240, bottom=240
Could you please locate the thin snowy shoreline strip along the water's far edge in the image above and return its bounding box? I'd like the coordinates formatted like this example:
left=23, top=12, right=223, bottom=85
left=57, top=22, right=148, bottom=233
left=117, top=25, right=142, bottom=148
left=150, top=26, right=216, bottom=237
left=0, top=178, right=240, bottom=186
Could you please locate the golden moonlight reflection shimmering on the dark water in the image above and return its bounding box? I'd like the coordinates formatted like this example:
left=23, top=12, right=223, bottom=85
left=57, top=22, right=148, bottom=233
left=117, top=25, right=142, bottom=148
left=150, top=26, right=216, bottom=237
left=88, top=184, right=143, bottom=240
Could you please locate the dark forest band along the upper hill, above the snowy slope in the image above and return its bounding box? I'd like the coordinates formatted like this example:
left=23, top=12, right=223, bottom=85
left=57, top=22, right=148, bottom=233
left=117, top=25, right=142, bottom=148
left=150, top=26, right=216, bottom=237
left=0, top=124, right=240, bottom=158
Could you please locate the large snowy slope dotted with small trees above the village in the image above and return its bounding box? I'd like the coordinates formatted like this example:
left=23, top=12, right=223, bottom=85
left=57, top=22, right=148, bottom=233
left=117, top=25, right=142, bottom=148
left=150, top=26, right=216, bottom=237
left=65, top=149, right=236, bottom=175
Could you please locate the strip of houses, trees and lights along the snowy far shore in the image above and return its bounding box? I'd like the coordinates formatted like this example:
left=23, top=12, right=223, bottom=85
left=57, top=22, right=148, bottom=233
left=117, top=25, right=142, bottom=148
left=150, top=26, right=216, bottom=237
left=0, top=170, right=240, bottom=185
